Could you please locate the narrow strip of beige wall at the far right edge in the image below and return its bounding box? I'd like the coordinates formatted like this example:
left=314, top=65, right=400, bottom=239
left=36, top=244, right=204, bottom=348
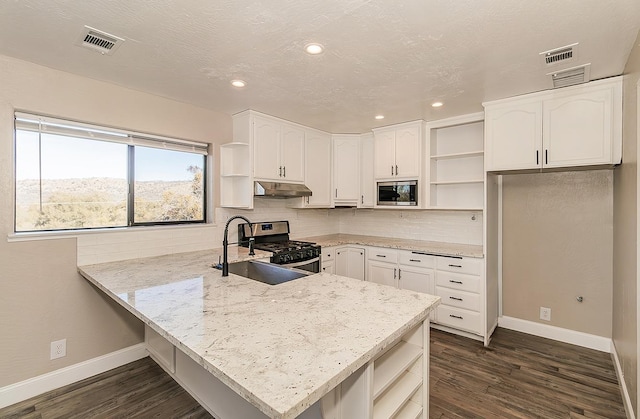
left=613, top=30, right=640, bottom=413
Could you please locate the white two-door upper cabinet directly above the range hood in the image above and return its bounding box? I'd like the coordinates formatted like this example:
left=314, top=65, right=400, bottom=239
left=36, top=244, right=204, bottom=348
left=253, top=115, right=305, bottom=183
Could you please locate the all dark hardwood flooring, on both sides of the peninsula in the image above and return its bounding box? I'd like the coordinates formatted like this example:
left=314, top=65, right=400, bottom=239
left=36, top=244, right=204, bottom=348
left=0, top=329, right=626, bottom=419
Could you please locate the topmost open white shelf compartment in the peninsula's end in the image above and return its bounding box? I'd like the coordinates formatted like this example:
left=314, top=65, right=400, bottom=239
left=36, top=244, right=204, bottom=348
left=373, top=341, right=422, bottom=399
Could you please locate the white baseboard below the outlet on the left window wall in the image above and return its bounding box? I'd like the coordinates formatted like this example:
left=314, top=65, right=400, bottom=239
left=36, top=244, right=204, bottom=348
left=0, top=343, right=149, bottom=409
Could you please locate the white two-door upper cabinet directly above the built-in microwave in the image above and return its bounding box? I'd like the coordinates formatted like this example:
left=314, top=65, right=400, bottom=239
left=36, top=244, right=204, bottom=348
left=373, top=121, right=423, bottom=179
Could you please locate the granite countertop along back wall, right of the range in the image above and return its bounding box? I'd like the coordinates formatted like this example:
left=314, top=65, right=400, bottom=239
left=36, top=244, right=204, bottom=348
left=299, top=234, right=484, bottom=258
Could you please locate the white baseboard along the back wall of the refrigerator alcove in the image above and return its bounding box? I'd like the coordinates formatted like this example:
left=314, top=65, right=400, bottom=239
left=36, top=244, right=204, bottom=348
left=498, top=316, right=611, bottom=353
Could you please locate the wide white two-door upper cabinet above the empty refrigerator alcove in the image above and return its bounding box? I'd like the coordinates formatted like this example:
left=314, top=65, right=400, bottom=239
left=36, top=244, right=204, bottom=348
left=484, top=77, right=622, bottom=171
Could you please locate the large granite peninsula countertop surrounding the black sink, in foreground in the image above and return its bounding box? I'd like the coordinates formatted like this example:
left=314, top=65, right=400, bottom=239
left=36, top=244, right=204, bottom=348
left=78, top=247, right=439, bottom=419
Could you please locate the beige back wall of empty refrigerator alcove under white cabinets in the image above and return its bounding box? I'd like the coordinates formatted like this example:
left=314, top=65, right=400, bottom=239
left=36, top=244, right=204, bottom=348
left=502, top=170, right=613, bottom=337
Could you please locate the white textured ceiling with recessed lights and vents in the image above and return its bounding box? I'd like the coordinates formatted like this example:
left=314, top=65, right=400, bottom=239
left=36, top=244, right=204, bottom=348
left=0, top=0, right=640, bottom=133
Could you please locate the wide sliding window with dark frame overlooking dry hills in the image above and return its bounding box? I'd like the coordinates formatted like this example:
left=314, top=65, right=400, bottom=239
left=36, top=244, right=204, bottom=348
left=15, top=113, right=207, bottom=232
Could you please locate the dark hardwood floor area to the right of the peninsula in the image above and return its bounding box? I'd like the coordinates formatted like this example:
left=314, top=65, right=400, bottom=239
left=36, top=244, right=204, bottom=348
left=429, top=328, right=626, bottom=419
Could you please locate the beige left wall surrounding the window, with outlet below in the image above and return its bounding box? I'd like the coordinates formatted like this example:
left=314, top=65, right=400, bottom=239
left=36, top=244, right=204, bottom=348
left=0, top=56, right=232, bottom=387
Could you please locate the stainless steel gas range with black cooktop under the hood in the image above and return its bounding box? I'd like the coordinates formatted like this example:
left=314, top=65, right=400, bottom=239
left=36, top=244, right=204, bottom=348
left=238, top=221, right=321, bottom=273
